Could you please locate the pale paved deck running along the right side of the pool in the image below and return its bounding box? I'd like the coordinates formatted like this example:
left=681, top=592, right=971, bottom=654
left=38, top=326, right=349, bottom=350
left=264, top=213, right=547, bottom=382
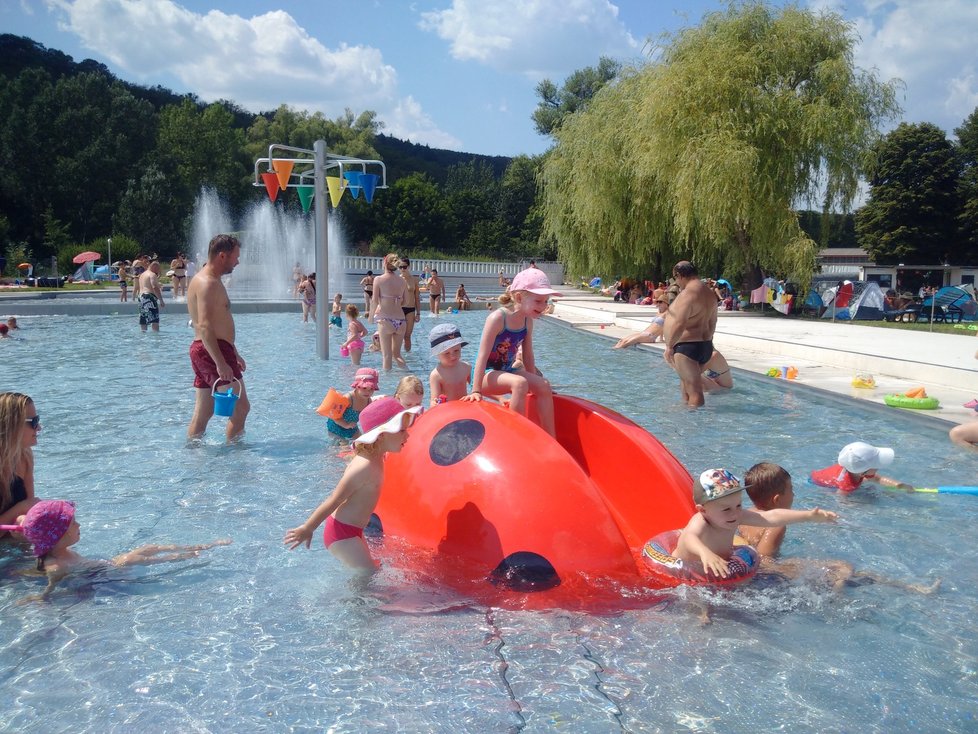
left=552, top=289, right=978, bottom=423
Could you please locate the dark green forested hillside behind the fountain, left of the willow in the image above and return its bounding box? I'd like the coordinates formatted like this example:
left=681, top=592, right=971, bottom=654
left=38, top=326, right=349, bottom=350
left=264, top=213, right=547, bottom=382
left=0, top=35, right=553, bottom=274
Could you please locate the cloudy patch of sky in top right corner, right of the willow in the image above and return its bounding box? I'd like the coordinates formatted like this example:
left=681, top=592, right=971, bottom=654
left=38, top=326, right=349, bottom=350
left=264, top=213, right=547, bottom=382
left=812, top=0, right=978, bottom=135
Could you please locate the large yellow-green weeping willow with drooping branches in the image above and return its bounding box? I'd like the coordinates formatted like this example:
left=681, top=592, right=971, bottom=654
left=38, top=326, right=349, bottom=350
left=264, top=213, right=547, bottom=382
left=541, top=3, right=899, bottom=284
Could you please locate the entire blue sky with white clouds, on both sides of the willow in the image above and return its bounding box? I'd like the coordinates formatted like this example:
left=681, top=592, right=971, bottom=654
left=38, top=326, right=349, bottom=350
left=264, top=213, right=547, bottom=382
left=0, top=0, right=978, bottom=155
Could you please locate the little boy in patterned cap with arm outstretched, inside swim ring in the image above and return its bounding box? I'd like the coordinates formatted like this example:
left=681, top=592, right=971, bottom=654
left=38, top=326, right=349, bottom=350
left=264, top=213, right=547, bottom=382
left=672, top=469, right=838, bottom=578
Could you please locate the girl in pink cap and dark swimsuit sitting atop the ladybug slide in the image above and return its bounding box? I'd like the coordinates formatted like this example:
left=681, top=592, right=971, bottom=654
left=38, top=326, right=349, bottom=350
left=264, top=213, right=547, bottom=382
left=462, top=267, right=562, bottom=436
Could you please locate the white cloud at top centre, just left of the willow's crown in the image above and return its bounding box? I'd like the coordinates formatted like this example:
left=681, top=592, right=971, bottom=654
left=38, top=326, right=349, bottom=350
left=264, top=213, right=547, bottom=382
left=420, top=0, right=641, bottom=80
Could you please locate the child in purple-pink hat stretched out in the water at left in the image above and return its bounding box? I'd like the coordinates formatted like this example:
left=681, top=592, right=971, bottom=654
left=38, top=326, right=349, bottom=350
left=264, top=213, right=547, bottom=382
left=0, top=500, right=231, bottom=599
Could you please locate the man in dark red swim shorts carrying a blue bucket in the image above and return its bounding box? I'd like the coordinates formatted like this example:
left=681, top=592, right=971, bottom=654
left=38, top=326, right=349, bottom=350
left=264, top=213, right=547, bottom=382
left=187, top=234, right=251, bottom=441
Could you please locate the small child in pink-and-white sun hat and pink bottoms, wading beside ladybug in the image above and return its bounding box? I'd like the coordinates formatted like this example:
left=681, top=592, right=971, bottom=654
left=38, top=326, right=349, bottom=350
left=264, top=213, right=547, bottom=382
left=283, top=398, right=421, bottom=573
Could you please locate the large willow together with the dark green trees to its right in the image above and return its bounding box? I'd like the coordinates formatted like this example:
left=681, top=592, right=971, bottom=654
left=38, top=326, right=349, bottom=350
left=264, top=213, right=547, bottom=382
left=533, top=2, right=978, bottom=288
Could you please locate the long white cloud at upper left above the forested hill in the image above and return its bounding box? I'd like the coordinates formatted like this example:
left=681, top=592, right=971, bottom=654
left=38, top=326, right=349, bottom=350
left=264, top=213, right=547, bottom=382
left=45, top=0, right=459, bottom=147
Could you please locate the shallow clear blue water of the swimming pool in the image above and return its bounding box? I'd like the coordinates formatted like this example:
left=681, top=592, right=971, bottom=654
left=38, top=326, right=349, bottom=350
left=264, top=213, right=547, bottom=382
left=0, top=312, right=978, bottom=732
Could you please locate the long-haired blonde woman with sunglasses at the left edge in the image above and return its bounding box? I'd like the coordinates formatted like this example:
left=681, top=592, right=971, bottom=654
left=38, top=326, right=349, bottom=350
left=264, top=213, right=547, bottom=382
left=0, top=392, right=41, bottom=535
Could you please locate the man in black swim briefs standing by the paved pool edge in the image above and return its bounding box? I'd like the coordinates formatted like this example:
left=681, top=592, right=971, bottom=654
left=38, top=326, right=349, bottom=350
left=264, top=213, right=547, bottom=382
left=663, top=260, right=717, bottom=408
